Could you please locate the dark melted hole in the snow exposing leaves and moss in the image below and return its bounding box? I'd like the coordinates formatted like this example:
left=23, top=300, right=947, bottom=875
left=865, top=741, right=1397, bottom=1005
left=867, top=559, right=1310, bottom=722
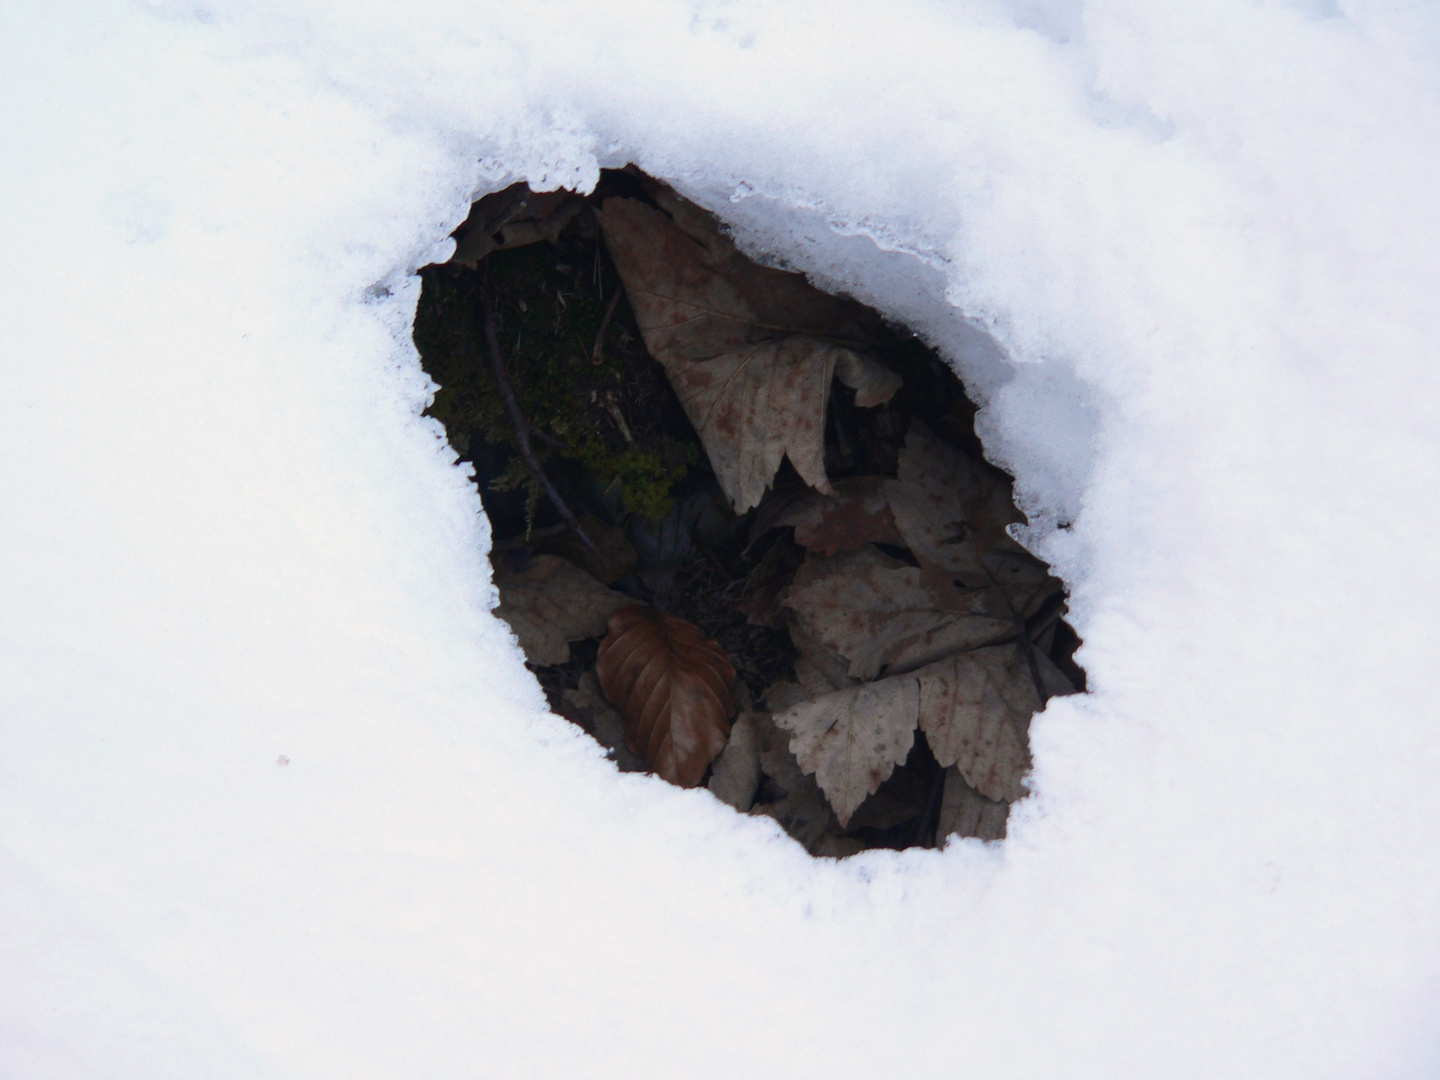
left=415, top=168, right=1084, bottom=857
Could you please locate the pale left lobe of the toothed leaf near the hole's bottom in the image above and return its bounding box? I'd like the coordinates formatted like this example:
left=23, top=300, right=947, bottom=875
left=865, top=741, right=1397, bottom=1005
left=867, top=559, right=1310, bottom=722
left=775, top=675, right=920, bottom=828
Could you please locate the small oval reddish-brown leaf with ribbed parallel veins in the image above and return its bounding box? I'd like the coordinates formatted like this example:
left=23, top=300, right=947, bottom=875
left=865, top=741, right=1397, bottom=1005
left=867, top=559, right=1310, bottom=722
left=595, top=603, right=734, bottom=788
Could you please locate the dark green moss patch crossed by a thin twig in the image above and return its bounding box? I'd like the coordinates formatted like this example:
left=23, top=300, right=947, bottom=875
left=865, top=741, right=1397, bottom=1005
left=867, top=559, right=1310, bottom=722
left=415, top=220, right=701, bottom=538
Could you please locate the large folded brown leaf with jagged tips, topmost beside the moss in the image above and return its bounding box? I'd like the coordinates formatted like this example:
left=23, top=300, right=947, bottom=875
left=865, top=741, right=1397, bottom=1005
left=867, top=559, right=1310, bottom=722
left=596, top=192, right=900, bottom=514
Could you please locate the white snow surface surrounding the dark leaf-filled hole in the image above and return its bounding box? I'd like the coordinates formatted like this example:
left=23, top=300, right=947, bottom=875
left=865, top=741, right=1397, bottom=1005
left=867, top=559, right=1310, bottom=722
left=0, top=0, right=1440, bottom=1080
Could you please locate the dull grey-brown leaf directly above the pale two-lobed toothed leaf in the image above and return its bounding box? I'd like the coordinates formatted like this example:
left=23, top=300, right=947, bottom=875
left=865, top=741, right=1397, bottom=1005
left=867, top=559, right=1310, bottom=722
left=785, top=546, right=1015, bottom=678
